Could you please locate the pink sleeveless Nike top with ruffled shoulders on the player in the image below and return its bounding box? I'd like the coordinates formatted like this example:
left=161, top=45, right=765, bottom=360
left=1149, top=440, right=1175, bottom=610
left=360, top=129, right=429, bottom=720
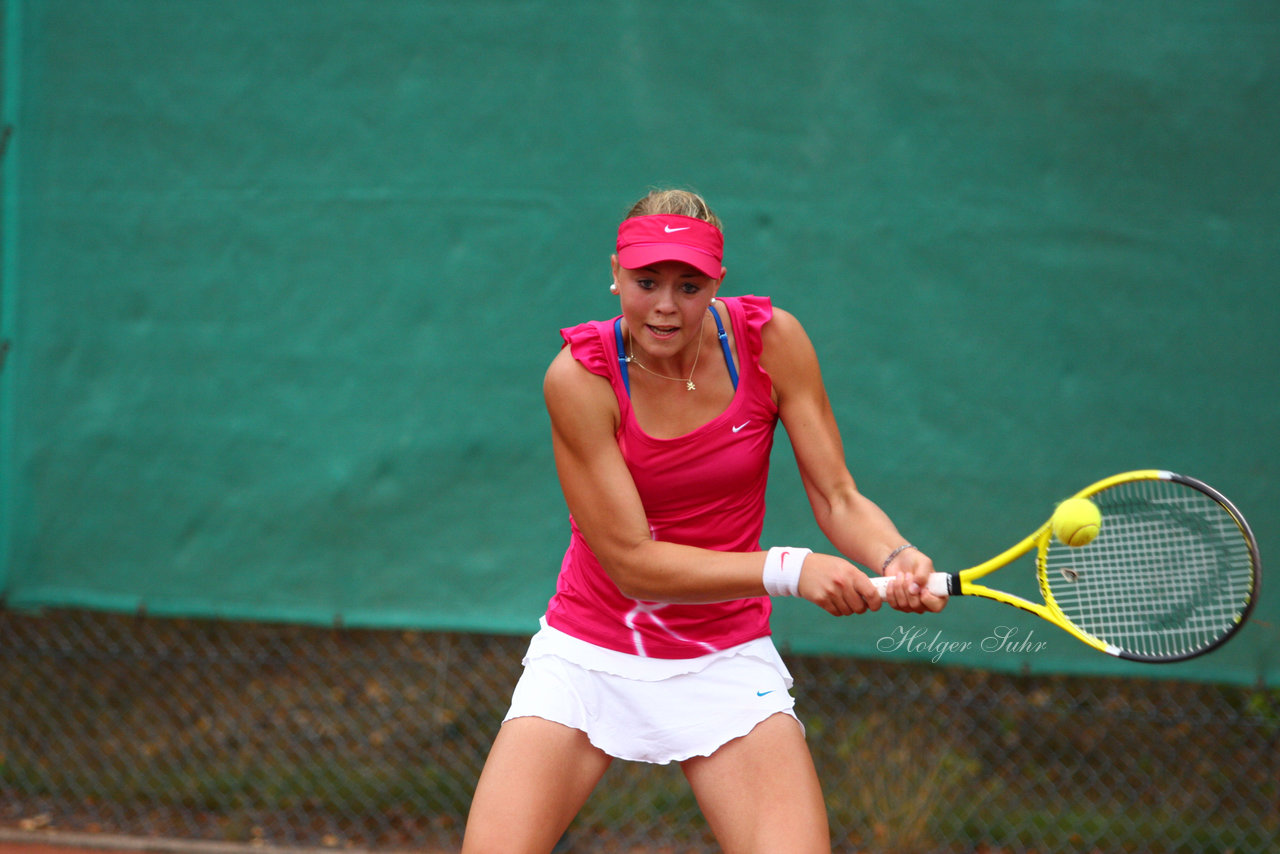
left=547, top=296, right=778, bottom=658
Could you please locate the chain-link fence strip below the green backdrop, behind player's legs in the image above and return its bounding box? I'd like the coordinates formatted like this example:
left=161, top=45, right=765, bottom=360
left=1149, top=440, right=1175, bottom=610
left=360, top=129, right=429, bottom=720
left=0, top=611, right=1280, bottom=854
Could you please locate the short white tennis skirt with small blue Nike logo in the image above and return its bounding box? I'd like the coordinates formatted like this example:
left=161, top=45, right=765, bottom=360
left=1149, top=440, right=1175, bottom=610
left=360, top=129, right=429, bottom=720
left=503, top=621, right=799, bottom=764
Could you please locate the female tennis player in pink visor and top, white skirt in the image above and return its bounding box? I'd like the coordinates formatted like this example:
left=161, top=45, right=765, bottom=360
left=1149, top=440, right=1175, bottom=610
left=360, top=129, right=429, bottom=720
left=462, top=191, right=945, bottom=854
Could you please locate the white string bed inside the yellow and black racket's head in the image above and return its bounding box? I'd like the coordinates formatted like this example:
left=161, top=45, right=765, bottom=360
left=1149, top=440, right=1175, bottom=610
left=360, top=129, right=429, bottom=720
left=1041, top=480, right=1254, bottom=658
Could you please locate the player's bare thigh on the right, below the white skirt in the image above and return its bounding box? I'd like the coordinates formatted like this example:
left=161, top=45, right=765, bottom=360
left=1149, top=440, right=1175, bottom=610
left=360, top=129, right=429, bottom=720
left=681, top=714, right=831, bottom=854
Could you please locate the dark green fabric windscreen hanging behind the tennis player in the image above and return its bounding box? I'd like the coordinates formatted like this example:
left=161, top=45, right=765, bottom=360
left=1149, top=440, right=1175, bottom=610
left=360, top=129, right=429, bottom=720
left=0, top=0, right=1280, bottom=684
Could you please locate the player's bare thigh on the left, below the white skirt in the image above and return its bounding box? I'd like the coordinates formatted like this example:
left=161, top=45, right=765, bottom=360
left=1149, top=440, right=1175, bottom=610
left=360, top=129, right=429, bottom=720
left=462, top=717, right=611, bottom=854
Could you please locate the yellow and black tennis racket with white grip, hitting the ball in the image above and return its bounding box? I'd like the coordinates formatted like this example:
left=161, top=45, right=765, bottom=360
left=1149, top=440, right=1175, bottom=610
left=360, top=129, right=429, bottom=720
left=872, top=470, right=1262, bottom=662
